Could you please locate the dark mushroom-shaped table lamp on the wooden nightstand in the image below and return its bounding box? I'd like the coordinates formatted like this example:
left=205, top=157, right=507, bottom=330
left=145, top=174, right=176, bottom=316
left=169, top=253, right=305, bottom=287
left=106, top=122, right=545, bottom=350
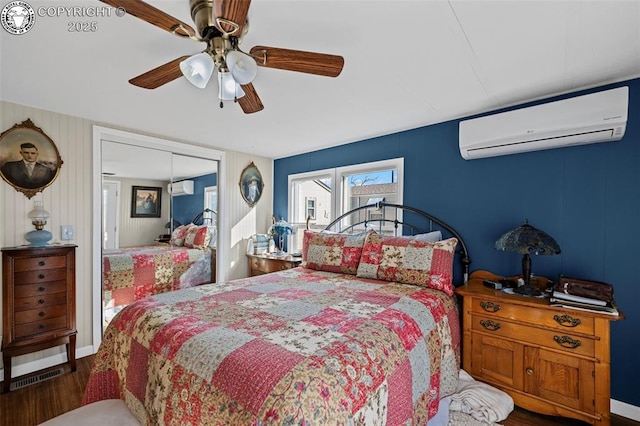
left=495, top=220, right=560, bottom=296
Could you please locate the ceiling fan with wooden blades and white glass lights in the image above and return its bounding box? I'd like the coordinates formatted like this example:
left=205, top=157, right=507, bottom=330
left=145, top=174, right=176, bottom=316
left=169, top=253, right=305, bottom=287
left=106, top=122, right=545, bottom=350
left=100, top=0, right=344, bottom=114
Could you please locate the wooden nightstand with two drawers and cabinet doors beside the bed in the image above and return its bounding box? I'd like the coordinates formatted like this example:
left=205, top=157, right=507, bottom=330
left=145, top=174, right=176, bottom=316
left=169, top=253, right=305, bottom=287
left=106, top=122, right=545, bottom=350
left=456, top=274, right=624, bottom=425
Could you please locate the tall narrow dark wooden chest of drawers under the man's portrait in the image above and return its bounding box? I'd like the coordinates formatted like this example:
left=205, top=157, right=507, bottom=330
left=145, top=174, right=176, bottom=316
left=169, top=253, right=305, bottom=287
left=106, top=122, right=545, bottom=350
left=2, top=245, right=77, bottom=392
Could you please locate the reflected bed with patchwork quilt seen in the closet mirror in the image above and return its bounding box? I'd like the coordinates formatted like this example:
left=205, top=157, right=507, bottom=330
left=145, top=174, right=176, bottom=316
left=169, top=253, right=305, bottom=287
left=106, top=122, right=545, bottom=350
left=102, top=226, right=216, bottom=325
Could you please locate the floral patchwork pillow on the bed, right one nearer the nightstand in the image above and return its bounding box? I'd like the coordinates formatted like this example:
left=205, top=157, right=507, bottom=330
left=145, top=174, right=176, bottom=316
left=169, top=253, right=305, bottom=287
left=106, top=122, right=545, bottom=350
left=357, top=233, right=458, bottom=296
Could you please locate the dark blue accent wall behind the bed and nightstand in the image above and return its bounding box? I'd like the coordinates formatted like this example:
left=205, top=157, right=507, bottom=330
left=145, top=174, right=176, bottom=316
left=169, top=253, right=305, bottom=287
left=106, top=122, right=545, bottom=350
left=273, top=79, right=640, bottom=406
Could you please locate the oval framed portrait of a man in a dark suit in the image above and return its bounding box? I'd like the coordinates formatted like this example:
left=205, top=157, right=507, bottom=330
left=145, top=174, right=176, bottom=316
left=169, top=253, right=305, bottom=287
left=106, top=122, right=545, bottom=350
left=0, top=119, right=63, bottom=198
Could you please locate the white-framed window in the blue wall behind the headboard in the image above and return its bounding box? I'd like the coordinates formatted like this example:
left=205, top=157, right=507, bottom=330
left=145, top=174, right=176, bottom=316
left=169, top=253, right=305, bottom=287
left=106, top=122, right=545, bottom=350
left=288, top=158, right=404, bottom=252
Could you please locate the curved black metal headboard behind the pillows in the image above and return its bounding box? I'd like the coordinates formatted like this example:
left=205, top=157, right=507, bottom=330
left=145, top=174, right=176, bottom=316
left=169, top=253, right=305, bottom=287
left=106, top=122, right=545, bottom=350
left=318, top=201, right=471, bottom=283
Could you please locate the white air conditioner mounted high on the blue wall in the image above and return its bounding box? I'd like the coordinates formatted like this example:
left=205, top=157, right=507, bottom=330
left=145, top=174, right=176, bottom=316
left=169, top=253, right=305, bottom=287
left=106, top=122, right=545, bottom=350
left=459, top=86, right=629, bottom=160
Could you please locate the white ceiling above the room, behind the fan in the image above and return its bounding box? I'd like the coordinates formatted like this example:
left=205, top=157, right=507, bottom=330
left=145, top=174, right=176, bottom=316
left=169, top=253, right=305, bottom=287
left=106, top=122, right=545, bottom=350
left=0, top=0, right=640, bottom=164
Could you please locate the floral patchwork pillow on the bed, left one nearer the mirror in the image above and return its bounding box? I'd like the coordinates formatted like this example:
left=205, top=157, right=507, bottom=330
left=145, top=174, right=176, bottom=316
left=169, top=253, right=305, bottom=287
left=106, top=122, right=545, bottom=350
left=302, top=230, right=372, bottom=275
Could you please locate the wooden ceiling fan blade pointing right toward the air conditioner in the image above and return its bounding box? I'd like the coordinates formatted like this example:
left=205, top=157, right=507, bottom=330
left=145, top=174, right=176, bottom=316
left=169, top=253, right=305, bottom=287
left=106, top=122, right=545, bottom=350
left=250, top=46, right=344, bottom=77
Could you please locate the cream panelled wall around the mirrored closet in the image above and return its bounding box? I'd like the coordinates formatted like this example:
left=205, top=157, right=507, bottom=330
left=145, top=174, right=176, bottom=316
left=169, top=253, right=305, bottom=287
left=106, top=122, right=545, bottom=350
left=0, top=101, right=273, bottom=376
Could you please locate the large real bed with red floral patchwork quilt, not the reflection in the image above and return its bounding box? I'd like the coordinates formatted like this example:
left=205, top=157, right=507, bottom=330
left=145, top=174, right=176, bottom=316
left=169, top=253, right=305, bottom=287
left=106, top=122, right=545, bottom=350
left=84, top=204, right=469, bottom=425
